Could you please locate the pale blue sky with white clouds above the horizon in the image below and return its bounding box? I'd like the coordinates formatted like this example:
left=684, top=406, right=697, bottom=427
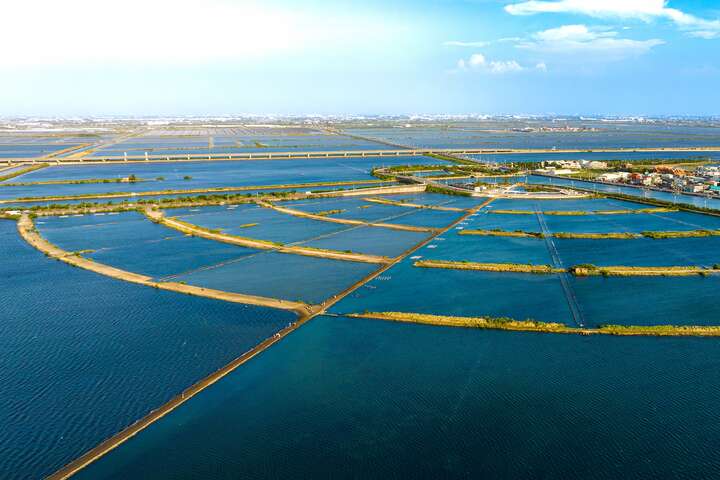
left=0, top=0, right=720, bottom=117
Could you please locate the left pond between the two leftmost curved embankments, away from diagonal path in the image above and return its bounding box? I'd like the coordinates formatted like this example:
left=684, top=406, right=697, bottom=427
left=36, top=212, right=258, bottom=279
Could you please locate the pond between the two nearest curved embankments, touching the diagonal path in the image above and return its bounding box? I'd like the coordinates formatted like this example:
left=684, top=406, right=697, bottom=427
left=174, top=252, right=379, bottom=303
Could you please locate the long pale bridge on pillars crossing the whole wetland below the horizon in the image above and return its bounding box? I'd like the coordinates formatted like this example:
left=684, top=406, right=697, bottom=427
left=0, top=146, right=720, bottom=165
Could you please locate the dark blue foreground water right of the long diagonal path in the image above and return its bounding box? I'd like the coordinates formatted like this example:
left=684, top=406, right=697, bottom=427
left=74, top=317, right=720, bottom=480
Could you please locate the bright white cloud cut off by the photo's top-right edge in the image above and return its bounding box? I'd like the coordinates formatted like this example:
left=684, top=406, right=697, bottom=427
left=505, top=0, right=720, bottom=38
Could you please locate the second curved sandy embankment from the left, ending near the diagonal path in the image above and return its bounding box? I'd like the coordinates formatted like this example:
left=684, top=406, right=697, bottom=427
left=144, top=208, right=391, bottom=264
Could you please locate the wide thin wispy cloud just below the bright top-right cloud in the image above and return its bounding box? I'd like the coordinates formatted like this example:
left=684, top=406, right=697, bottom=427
left=517, top=25, right=665, bottom=61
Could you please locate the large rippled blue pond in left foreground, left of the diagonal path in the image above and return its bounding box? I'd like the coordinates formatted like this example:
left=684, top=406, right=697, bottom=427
left=0, top=220, right=295, bottom=479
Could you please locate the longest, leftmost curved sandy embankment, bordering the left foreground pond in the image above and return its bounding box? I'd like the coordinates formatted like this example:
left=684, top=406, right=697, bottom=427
left=17, top=215, right=313, bottom=315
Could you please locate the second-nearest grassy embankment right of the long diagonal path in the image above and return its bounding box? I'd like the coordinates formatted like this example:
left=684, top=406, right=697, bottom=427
left=413, top=260, right=720, bottom=277
